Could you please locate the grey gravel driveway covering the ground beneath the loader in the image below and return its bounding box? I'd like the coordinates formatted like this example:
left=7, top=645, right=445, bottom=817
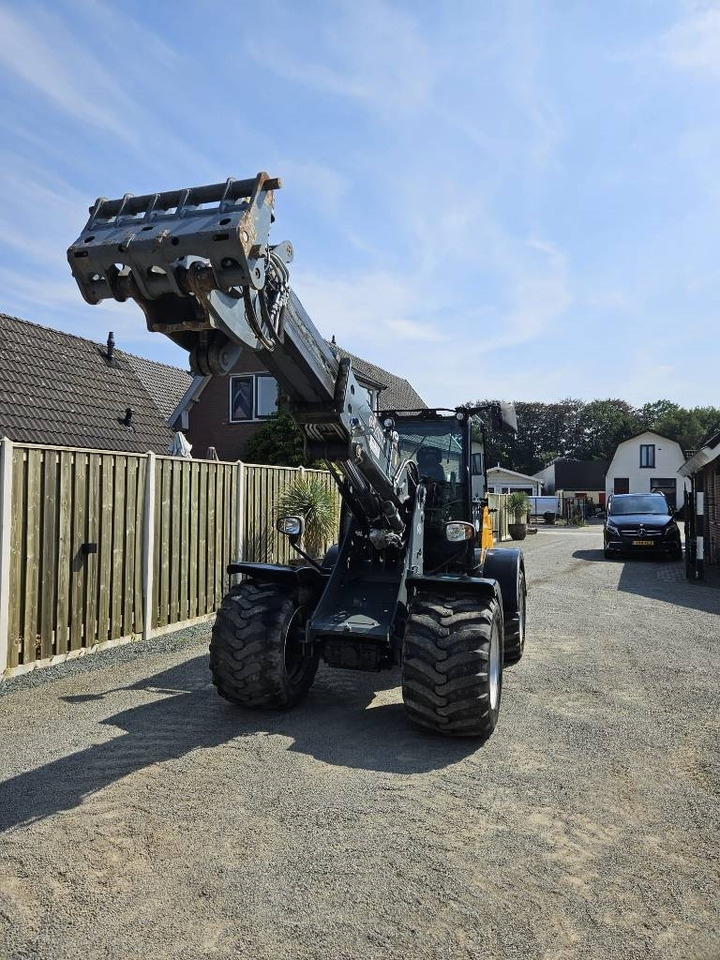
left=0, top=527, right=720, bottom=960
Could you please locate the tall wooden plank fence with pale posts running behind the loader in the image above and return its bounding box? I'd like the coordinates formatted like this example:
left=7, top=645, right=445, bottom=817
left=0, top=439, right=508, bottom=677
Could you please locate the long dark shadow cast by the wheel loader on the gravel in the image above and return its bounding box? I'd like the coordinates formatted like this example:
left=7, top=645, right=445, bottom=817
left=0, top=655, right=481, bottom=831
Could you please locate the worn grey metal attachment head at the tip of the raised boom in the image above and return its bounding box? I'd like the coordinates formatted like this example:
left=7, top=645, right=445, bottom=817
left=67, top=172, right=292, bottom=373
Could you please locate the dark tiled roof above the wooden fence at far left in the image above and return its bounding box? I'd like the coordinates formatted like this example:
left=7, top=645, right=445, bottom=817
left=0, top=313, right=192, bottom=453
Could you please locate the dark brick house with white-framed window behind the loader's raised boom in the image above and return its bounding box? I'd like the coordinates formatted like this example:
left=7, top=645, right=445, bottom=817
left=170, top=343, right=427, bottom=460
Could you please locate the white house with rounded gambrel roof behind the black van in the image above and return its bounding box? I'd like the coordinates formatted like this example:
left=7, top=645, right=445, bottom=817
left=605, top=430, right=687, bottom=507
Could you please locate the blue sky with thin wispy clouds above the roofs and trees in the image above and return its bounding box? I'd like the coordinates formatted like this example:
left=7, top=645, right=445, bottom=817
left=0, top=0, right=720, bottom=406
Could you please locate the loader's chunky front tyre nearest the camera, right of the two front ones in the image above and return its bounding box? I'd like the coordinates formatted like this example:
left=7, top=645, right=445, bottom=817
left=402, top=593, right=503, bottom=739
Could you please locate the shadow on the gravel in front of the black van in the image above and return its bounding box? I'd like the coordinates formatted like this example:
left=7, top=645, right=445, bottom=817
left=573, top=550, right=720, bottom=613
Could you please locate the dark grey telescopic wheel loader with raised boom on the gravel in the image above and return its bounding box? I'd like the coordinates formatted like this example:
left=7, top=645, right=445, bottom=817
left=68, top=173, right=526, bottom=737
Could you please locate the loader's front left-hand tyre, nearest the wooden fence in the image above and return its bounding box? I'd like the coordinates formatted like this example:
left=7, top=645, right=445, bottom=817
left=210, top=580, right=318, bottom=710
